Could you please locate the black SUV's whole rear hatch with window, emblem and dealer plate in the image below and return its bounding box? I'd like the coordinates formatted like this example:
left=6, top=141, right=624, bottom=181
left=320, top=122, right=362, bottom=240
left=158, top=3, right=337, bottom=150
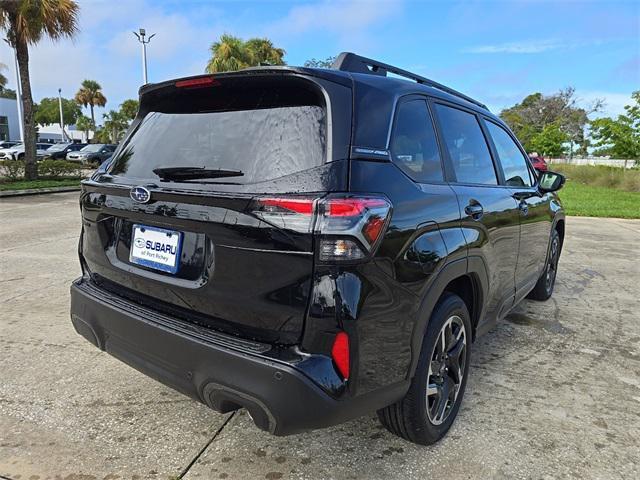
left=81, top=69, right=351, bottom=344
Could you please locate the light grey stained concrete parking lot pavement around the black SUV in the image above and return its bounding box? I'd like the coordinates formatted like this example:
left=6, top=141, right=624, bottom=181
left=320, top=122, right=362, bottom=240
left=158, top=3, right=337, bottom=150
left=0, top=189, right=640, bottom=480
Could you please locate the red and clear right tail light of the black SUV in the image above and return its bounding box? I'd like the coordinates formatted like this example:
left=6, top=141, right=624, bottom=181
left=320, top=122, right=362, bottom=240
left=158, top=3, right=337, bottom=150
left=252, top=194, right=391, bottom=262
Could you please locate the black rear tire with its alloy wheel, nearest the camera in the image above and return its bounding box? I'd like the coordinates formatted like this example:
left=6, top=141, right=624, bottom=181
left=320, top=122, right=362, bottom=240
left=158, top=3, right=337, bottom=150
left=378, top=293, right=471, bottom=445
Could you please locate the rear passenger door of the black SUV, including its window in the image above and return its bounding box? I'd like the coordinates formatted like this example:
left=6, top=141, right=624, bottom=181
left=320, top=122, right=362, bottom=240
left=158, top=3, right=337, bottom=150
left=434, top=101, right=520, bottom=320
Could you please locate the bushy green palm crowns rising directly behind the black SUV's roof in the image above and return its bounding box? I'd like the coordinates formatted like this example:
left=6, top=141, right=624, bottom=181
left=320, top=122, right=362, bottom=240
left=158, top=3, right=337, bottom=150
left=205, top=33, right=286, bottom=73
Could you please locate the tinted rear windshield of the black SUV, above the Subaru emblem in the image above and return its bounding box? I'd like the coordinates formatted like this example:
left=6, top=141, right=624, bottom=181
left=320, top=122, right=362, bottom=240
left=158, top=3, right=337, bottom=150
left=110, top=79, right=327, bottom=184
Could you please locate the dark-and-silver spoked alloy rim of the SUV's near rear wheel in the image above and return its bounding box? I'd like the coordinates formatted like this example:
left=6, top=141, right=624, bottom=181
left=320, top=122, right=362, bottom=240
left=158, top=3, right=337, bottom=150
left=426, top=315, right=467, bottom=425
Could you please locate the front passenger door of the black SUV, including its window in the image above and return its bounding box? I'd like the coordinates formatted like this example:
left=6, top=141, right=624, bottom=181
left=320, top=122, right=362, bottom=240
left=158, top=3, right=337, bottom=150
left=485, top=119, right=553, bottom=299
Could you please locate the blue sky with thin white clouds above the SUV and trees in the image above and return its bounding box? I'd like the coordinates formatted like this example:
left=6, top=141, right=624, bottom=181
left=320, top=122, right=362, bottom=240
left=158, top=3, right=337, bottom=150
left=0, top=0, right=640, bottom=124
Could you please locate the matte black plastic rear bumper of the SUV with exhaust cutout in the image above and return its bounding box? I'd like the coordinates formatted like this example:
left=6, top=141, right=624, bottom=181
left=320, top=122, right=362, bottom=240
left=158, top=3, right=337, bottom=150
left=71, top=279, right=407, bottom=435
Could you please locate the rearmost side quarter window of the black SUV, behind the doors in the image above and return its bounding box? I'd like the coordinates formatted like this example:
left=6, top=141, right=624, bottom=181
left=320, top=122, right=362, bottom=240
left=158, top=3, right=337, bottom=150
left=391, top=100, right=444, bottom=183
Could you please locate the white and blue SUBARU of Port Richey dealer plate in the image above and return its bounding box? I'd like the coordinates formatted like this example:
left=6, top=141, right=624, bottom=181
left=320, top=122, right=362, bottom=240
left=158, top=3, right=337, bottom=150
left=129, top=225, right=182, bottom=273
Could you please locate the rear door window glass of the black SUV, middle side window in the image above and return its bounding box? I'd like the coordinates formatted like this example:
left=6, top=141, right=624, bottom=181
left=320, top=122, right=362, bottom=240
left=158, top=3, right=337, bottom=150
left=435, top=103, right=498, bottom=185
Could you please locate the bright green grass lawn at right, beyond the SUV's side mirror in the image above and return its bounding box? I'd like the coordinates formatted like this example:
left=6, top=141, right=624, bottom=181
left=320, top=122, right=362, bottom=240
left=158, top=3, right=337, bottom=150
left=559, top=180, right=640, bottom=218
